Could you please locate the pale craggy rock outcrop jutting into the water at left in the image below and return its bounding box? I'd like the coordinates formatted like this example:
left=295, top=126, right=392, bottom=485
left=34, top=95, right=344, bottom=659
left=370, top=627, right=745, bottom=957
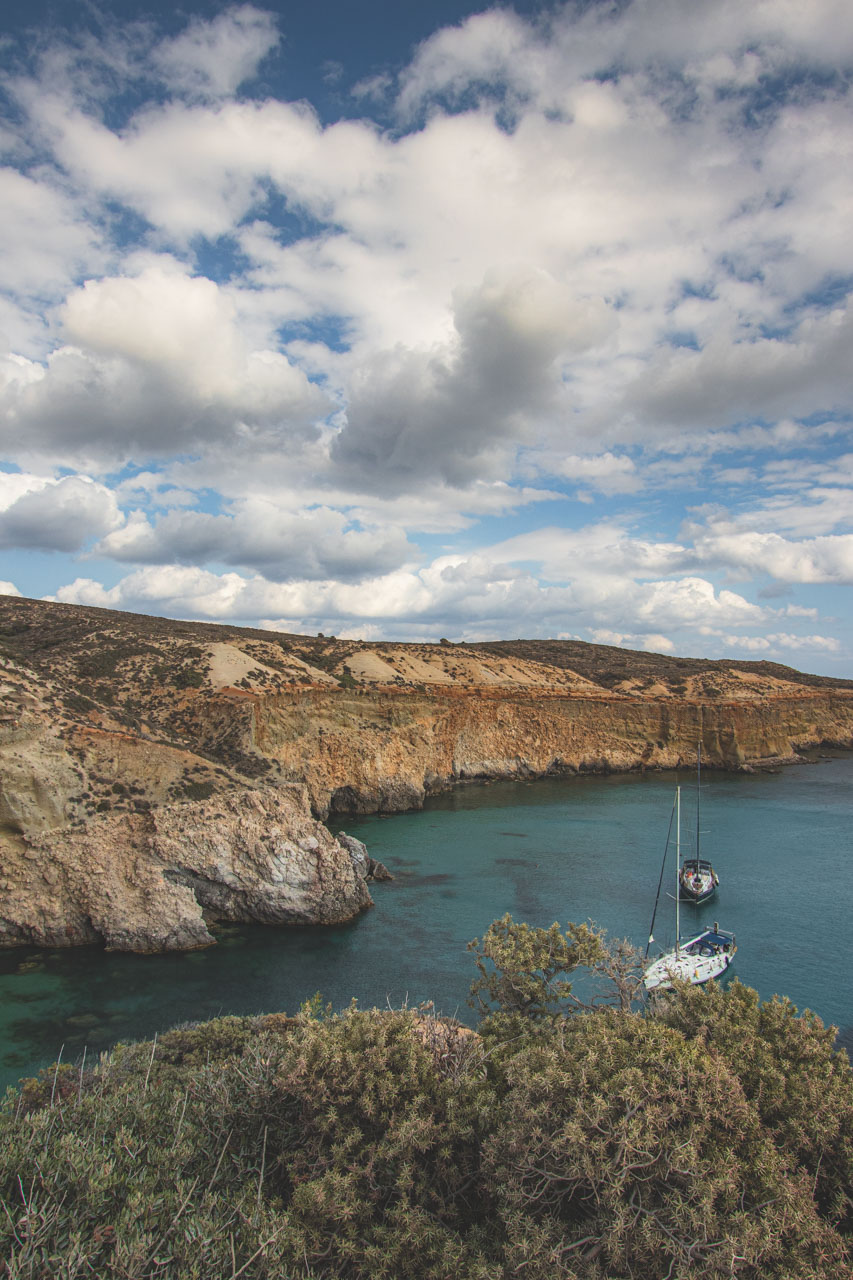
left=0, top=786, right=371, bottom=951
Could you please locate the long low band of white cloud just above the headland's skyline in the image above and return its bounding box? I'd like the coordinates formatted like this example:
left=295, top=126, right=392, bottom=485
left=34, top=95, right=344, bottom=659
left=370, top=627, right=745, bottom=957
left=58, top=556, right=767, bottom=650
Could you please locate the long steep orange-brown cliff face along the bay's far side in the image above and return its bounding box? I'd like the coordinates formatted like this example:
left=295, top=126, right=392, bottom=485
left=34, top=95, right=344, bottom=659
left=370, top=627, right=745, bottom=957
left=247, top=689, right=853, bottom=814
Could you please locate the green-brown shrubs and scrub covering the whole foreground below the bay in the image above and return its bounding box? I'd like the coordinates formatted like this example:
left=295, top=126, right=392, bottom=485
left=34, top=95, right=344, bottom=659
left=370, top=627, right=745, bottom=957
left=0, top=916, right=853, bottom=1280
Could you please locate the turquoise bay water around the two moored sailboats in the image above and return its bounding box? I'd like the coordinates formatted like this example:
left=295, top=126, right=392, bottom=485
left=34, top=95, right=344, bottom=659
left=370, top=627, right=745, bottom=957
left=0, top=756, right=853, bottom=1087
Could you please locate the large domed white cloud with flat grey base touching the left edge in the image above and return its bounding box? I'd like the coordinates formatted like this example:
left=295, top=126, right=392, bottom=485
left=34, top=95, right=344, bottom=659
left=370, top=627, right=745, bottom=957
left=0, top=260, right=329, bottom=462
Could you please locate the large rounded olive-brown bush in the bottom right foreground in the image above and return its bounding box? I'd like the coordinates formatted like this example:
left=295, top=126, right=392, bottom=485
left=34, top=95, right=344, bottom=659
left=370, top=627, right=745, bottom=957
left=483, top=1010, right=844, bottom=1280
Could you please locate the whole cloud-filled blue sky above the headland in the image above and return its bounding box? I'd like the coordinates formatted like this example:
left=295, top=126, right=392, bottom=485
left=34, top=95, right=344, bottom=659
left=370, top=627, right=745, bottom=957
left=0, top=0, right=853, bottom=677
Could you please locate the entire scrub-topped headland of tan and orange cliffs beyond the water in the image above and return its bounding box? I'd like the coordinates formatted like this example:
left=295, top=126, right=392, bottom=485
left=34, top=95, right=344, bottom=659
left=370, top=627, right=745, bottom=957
left=0, top=596, right=853, bottom=951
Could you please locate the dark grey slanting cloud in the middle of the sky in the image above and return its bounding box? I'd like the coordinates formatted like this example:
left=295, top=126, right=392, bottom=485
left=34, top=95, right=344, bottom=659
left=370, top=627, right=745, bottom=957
left=332, top=271, right=612, bottom=489
